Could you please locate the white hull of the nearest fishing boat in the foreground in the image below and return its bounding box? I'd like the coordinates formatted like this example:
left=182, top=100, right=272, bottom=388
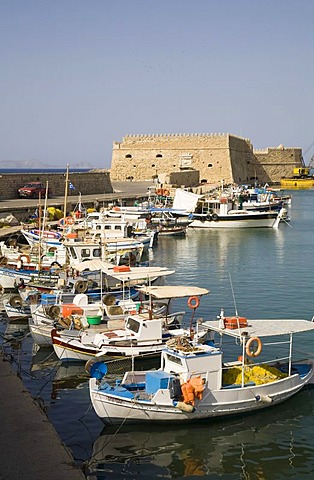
left=89, top=370, right=313, bottom=425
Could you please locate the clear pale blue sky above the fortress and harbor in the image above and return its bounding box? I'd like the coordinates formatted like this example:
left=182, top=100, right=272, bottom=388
left=0, top=0, right=314, bottom=168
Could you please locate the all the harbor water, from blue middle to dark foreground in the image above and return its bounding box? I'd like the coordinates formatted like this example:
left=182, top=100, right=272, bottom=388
left=1, top=190, right=314, bottom=480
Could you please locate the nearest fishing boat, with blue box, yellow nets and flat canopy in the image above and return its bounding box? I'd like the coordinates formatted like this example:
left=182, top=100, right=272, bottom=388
left=89, top=312, right=314, bottom=425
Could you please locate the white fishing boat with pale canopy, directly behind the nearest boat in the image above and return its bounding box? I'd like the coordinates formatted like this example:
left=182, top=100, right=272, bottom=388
left=51, top=286, right=209, bottom=361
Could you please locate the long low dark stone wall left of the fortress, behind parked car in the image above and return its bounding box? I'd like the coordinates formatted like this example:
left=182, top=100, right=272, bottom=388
left=0, top=171, right=113, bottom=199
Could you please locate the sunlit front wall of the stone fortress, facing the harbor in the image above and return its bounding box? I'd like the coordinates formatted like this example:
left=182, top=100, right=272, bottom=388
left=110, top=134, right=245, bottom=182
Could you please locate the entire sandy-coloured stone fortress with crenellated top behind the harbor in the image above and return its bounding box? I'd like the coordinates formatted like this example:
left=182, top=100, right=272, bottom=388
left=110, top=133, right=303, bottom=185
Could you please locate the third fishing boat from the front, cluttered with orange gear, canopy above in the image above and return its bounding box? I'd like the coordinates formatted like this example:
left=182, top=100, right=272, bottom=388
left=29, top=266, right=174, bottom=348
